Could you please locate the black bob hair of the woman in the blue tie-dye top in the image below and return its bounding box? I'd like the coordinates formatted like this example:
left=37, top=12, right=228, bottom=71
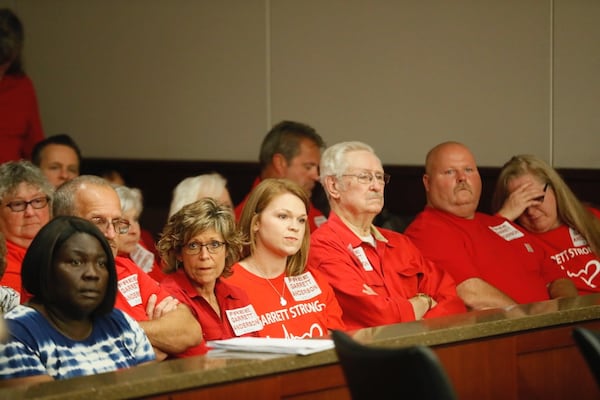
left=21, top=216, right=117, bottom=316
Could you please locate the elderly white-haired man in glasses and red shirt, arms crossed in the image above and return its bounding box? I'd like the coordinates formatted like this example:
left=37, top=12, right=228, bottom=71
left=308, top=142, right=466, bottom=329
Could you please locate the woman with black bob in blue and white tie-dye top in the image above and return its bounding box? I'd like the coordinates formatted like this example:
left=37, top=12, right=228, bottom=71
left=0, top=217, right=155, bottom=387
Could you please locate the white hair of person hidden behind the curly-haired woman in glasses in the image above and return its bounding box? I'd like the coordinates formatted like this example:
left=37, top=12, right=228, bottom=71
left=169, top=172, right=227, bottom=217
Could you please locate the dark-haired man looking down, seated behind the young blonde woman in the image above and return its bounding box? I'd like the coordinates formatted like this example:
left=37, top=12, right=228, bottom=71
left=235, top=121, right=327, bottom=232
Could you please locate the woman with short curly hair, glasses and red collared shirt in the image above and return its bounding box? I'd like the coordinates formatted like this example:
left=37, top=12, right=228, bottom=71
left=157, top=198, right=262, bottom=357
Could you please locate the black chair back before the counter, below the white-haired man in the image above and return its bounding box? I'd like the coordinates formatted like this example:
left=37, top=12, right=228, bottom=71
left=331, top=331, right=457, bottom=400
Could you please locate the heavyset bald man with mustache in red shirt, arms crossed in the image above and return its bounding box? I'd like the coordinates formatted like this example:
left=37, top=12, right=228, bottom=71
left=405, top=142, right=577, bottom=310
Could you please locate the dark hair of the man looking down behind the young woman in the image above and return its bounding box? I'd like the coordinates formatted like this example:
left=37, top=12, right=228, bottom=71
left=259, top=121, right=325, bottom=169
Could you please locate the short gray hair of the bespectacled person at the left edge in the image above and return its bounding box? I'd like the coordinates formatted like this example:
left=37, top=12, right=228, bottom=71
left=0, top=160, right=54, bottom=209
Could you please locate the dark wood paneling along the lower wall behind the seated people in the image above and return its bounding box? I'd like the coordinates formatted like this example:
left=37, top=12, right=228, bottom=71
left=82, top=158, right=600, bottom=241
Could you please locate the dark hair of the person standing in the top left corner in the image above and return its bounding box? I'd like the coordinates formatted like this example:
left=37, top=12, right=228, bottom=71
left=0, top=8, right=25, bottom=75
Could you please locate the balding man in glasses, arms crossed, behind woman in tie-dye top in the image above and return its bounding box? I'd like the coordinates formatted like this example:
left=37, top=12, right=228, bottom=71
left=53, top=175, right=202, bottom=360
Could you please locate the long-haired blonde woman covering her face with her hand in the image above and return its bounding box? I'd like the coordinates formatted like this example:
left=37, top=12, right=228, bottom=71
left=492, top=155, right=600, bottom=294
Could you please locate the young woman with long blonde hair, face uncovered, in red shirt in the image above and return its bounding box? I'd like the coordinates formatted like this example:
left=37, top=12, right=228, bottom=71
left=228, top=179, right=345, bottom=338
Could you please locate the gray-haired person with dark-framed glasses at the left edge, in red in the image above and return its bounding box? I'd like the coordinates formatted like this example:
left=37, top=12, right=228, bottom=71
left=0, top=160, right=54, bottom=302
